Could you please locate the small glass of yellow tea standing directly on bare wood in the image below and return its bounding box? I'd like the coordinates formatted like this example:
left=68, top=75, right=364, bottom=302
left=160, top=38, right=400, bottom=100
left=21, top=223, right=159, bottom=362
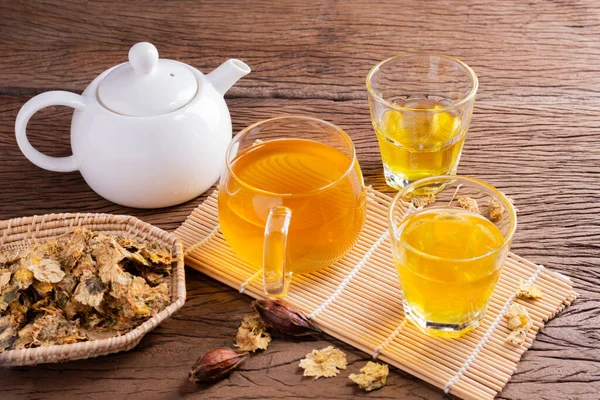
left=367, top=54, right=478, bottom=189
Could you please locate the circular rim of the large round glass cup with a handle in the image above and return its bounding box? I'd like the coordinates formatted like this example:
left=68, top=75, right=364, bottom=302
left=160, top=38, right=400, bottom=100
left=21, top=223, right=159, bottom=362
left=225, top=115, right=357, bottom=197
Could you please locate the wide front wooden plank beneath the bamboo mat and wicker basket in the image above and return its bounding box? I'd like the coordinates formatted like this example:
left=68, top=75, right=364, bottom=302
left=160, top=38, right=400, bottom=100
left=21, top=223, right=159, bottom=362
left=0, top=96, right=600, bottom=399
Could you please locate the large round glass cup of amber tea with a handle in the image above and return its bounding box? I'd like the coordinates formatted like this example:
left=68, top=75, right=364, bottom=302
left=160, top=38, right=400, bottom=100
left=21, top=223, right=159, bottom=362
left=219, top=116, right=366, bottom=297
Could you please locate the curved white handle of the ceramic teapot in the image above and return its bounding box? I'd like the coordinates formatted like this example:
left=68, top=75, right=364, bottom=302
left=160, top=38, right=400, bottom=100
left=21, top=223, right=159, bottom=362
left=15, top=90, right=86, bottom=172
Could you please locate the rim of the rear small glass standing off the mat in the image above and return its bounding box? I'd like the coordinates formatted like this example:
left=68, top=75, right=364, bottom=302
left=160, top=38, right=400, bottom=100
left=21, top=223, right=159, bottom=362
left=366, top=53, right=479, bottom=113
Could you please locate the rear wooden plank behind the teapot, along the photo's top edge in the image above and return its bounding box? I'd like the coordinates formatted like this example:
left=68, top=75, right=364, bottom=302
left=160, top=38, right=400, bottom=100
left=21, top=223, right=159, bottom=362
left=0, top=0, right=600, bottom=104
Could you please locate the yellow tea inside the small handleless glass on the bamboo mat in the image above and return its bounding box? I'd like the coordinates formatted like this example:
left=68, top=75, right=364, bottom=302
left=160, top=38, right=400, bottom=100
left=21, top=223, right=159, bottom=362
left=394, top=208, right=504, bottom=337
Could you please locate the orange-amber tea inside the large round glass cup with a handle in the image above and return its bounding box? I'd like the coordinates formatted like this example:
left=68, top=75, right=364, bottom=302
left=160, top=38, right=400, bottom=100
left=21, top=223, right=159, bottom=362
left=219, top=139, right=366, bottom=273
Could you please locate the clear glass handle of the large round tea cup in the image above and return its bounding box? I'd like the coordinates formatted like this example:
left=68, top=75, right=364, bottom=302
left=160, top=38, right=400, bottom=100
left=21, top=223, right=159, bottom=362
left=263, top=206, right=292, bottom=297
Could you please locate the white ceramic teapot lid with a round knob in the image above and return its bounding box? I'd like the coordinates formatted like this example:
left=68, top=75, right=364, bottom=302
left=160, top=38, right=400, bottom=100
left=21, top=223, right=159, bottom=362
left=98, top=42, right=198, bottom=117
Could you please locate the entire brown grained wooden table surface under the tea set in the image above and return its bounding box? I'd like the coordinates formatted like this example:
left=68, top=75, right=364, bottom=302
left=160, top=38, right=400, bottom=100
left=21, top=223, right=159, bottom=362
left=0, top=0, right=600, bottom=399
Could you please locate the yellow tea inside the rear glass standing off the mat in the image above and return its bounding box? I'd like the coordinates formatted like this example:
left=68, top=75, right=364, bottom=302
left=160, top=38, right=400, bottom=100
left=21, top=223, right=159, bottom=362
left=374, top=99, right=467, bottom=188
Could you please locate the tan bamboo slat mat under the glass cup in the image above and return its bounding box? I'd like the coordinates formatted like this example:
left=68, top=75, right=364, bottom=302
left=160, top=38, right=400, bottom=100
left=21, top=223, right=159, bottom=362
left=174, top=188, right=577, bottom=399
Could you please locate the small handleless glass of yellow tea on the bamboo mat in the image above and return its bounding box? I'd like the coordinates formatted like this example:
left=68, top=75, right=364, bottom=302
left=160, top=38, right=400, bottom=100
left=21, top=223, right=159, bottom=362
left=389, top=175, right=517, bottom=337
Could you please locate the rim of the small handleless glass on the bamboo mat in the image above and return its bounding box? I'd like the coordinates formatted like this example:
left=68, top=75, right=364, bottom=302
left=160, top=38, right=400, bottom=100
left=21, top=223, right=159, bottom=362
left=388, top=175, right=517, bottom=267
